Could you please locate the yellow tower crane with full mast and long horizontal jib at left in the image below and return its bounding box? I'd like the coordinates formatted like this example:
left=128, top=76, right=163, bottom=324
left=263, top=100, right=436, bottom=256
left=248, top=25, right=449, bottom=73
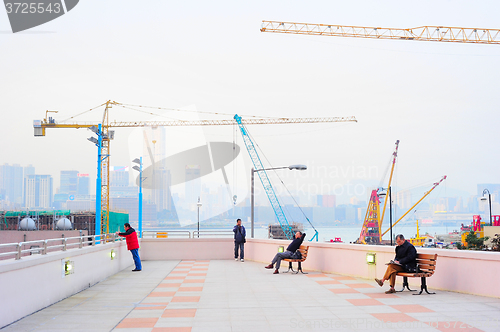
left=33, top=100, right=357, bottom=234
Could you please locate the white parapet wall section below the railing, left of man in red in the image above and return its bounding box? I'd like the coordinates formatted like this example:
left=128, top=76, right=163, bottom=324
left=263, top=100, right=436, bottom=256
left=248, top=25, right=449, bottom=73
left=0, top=241, right=133, bottom=329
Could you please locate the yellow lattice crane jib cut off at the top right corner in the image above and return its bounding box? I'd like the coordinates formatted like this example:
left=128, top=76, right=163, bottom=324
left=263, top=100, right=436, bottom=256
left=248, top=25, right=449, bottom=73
left=260, top=21, right=500, bottom=44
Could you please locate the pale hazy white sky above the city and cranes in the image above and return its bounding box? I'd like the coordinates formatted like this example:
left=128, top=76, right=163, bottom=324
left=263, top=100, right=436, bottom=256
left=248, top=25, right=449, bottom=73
left=0, top=0, right=500, bottom=205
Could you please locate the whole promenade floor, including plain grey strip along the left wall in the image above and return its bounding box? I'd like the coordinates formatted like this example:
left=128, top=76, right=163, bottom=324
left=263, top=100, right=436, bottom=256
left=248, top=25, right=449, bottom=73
left=2, top=260, right=500, bottom=332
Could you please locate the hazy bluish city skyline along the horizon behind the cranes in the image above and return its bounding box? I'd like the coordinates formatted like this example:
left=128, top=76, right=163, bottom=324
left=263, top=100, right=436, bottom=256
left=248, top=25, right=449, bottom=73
left=0, top=164, right=500, bottom=212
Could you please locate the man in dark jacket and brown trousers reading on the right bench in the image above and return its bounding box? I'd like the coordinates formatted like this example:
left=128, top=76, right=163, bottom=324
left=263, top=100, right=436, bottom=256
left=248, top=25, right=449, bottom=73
left=375, top=234, right=417, bottom=294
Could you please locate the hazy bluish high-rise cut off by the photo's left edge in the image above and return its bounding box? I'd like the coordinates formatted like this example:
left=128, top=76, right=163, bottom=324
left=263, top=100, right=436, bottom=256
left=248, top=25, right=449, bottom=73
left=0, top=164, right=23, bottom=207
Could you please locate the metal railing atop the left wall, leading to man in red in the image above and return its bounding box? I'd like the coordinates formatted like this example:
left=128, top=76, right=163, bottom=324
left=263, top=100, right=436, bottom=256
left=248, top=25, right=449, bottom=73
left=0, top=233, right=124, bottom=260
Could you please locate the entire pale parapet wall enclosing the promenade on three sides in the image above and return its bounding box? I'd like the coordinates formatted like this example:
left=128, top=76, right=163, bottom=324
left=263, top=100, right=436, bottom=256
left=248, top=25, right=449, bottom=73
left=0, top=238, right=500, bottom=328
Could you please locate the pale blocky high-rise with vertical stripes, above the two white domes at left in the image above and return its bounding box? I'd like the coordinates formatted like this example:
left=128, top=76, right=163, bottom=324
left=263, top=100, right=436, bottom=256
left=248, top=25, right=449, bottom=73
left=24, top=175, right=53, bottom=209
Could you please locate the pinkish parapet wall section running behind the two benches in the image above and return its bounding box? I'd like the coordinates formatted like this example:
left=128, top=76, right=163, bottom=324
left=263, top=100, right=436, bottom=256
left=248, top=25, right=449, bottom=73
left=245, top=239, right=500, bottom=297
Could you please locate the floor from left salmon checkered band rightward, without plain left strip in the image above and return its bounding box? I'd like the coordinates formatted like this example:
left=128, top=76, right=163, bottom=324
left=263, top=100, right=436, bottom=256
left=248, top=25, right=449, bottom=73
left=112, top=261, right=500, bottom=332
